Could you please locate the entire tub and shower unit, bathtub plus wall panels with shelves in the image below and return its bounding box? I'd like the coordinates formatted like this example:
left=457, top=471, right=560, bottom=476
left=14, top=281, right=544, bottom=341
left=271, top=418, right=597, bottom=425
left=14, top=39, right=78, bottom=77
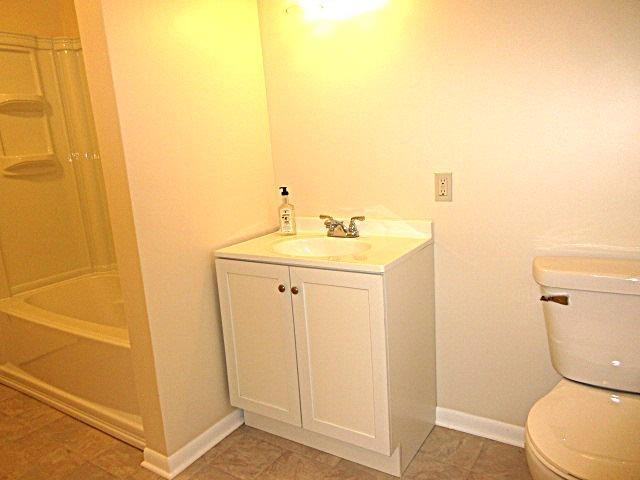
left=0, top=33, right=144, bottom=447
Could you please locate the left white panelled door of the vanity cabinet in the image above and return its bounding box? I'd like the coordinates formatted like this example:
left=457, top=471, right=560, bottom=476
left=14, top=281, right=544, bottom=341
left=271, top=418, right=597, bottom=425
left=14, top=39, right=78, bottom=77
left=216, top=259, right=301, bottom=426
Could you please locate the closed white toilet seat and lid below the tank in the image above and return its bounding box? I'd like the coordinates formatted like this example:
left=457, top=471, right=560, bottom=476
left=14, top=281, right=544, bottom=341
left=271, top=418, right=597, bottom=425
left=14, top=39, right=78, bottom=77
left=526, top=379, right=640, bottom=480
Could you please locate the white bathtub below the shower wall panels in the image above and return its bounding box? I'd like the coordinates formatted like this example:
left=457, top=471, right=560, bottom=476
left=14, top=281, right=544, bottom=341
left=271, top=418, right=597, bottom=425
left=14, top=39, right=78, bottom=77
left=0, top=272, right=144, bottom=447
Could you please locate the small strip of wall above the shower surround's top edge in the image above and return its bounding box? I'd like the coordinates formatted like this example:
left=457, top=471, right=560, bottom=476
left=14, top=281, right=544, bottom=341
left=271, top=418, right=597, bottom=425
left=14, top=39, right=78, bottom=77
left=0, top=0, right=78, bottom=37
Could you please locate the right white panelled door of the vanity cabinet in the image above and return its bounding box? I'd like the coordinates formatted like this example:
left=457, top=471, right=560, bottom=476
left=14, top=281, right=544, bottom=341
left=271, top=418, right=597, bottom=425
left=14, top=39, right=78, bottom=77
left=291, top=267, right=391, bottom=455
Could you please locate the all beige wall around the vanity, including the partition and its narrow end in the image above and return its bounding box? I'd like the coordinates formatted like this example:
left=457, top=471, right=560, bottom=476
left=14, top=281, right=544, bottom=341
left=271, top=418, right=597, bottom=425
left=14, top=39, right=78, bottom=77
left=72, top=0, right=640, bottom=453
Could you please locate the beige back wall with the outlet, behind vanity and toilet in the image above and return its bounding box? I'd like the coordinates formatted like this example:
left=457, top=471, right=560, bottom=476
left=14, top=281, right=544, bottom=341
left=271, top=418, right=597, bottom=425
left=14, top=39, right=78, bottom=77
left=259, top=0, right=640, bottom=425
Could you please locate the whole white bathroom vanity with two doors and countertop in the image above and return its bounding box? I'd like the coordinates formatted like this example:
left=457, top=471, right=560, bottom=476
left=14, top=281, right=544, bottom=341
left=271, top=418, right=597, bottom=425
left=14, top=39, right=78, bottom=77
left=216, top=219, right=436, bottom=476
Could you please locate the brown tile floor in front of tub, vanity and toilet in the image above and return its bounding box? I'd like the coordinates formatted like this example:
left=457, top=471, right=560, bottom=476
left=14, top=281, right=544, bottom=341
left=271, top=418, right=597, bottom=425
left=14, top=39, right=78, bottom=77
left=0, top=385, right=531, bottom=480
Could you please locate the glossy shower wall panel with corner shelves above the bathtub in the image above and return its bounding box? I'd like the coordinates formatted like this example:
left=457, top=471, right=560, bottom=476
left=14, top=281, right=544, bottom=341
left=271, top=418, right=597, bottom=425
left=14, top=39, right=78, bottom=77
left=0, top=33, right=114, bottom=298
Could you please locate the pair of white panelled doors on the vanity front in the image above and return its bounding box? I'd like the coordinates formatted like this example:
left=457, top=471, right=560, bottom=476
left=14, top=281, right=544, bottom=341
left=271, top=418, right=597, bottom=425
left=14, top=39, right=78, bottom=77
left=216, top=259, right=390, bottom=455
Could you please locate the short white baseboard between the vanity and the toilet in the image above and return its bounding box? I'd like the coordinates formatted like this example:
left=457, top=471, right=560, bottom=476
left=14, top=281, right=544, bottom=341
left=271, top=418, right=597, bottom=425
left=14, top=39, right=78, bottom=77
left=436, top=407, right=524, bottom=447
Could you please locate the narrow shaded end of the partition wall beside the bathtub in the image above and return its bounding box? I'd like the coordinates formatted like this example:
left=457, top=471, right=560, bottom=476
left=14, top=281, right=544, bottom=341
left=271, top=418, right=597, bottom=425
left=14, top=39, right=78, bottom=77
left=77, top=0, right=167, bottom=452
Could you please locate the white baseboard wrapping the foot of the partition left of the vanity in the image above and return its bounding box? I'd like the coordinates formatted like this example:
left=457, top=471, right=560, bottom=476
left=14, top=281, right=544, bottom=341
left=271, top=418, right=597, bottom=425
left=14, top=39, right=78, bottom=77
left=142, top=410, right=244, bottom=479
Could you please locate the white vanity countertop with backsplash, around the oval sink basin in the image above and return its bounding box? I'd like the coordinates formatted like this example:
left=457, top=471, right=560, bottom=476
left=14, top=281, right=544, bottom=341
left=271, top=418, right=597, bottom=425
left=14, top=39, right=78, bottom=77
left=215, top=217, right=433, bottom=274
